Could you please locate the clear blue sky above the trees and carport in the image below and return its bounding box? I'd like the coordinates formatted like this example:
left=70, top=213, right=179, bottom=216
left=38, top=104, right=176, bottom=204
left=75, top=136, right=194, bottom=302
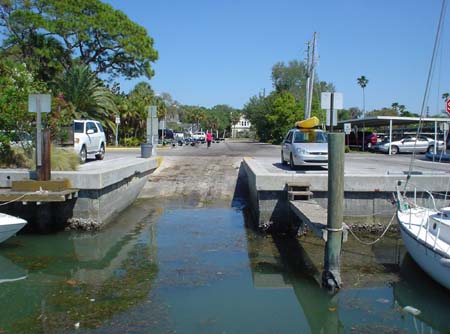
left=105, top=0, right=450, bottom=114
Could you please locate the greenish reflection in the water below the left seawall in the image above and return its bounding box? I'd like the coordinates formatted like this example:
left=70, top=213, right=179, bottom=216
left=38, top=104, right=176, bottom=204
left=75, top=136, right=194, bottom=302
left=0, top=202, right=158, bottom=333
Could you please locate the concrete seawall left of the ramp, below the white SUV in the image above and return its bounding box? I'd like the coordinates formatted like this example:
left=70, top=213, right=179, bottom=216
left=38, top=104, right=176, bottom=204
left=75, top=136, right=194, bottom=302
left=0, top=157, right=157, bottom=229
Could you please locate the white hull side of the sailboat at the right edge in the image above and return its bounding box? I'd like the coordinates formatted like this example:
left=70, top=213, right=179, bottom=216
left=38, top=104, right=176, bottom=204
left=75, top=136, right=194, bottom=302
left=398, top=212, right=450, bottom=290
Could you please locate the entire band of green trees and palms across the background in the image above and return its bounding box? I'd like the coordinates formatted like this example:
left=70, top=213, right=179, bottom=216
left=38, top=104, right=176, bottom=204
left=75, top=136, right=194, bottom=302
left=0, top=0, right=448, bottom=160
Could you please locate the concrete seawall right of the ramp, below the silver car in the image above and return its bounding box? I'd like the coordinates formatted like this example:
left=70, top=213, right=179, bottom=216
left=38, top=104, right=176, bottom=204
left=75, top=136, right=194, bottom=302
left=242, top=158, right=449, bottom=230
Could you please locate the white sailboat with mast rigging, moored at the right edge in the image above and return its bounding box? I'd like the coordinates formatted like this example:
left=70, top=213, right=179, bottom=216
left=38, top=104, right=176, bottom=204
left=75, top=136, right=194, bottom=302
left=396, top=0, right=450, bottom=290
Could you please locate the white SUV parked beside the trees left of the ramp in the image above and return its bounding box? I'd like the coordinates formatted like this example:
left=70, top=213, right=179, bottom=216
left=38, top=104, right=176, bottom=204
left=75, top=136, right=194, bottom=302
left=73, top=120, right=106, bottom=163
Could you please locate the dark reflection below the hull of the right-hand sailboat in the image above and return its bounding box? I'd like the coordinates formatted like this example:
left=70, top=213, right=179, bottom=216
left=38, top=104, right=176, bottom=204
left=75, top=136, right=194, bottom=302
left=393, top=254, right=450, bottom=333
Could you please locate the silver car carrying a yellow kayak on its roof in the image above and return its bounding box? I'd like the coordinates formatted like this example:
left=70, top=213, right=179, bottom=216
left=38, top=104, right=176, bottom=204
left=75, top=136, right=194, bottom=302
left=281, top=128, right=328, bottom=169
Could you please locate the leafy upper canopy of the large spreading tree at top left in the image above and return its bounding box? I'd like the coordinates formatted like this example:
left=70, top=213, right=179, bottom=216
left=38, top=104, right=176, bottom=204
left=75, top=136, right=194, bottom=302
left=0, top=0, right=158, bottom=78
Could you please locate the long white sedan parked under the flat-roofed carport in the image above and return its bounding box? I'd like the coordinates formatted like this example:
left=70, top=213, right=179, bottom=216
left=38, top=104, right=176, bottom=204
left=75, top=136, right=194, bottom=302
left=376, top=136, right=444, bottom=154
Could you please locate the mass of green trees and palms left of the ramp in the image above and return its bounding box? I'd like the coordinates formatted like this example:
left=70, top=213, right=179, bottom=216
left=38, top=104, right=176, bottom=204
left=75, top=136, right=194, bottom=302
left=0, top=0, right=243, bottom=160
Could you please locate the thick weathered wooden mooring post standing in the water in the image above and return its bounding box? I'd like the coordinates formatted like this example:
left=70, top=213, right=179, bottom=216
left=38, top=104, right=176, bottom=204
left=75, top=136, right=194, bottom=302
left=322, top=133, right=345, bottom=292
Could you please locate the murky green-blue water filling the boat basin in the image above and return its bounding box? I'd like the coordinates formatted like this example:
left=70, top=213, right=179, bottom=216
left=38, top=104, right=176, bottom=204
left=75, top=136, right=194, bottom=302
left=0, top=201, right=450, bottom=333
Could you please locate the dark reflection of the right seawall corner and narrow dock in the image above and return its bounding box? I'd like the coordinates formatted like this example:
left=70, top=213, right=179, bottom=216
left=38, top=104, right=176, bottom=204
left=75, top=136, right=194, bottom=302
left=248, top=232, right=343, bottom=334
